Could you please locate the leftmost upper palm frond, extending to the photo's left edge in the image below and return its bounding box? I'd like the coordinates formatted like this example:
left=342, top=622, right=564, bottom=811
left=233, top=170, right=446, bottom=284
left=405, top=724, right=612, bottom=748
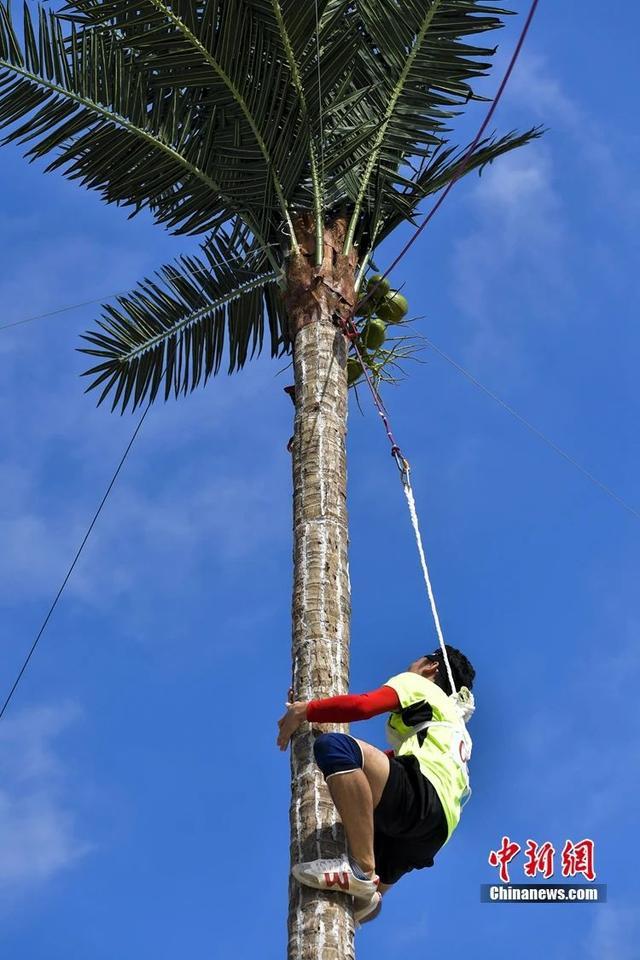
left=0, top=2, right=255, bottom=233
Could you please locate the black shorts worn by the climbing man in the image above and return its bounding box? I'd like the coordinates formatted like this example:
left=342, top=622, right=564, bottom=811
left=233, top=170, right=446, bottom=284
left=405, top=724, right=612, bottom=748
left=373, top=756, right=449, bottom=883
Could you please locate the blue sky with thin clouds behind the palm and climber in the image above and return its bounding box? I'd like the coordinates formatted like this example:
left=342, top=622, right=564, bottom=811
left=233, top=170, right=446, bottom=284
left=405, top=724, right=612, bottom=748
left=0, top=0, right=640, bottom=960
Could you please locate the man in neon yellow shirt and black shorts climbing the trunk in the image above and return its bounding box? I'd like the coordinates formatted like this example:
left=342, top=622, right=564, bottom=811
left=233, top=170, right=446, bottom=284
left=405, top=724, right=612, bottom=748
left=277, top=645, right=475, bottom=923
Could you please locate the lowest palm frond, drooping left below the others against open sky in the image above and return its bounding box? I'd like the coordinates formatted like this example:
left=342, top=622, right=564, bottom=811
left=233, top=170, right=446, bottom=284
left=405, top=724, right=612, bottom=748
left=82, top=230, right=289, bottom=412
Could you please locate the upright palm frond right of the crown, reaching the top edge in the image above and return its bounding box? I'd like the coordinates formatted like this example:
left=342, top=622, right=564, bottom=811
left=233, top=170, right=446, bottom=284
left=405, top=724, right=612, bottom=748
left=333, top=0, right=504, bottom=249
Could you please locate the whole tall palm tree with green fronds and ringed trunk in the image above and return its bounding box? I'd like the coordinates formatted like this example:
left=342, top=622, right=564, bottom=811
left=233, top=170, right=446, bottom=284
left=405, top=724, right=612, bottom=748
left=0, top=0, right=537, bottom=960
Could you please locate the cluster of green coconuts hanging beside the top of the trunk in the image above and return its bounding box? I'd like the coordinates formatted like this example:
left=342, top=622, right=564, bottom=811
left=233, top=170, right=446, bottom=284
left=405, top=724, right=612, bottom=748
left=347, top=273, right=409, bottom=386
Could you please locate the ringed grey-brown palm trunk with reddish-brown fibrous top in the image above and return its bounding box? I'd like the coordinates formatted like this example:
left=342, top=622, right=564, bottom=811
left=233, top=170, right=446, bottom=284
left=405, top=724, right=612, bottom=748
left=287, top=217, right=356, bottom=960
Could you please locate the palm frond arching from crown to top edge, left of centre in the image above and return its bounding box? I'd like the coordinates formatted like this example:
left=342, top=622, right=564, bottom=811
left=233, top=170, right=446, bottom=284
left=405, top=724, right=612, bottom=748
left=59, top=0, right=310, bottom=243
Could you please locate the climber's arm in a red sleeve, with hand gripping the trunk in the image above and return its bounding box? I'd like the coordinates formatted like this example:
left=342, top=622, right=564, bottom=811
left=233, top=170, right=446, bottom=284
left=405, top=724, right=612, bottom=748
left=277, top=685, right=400, bottom=750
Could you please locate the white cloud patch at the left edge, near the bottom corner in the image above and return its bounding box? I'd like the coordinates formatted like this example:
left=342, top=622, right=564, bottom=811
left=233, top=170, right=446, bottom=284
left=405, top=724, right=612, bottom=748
left=0, top=704, right=89, bottom=897
